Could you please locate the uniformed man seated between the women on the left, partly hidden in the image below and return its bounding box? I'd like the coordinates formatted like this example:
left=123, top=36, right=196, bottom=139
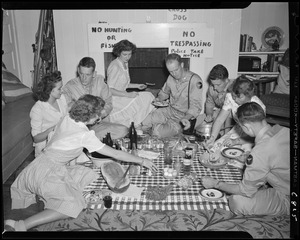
left=63, top=57, right=128, bottom=140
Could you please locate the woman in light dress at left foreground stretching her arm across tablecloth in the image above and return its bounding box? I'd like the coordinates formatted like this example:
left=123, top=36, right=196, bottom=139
left=4, top=95, right=157, bottom=231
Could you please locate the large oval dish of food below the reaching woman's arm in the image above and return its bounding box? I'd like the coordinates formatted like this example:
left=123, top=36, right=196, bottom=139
left=101, top=161, right=130, bottom=193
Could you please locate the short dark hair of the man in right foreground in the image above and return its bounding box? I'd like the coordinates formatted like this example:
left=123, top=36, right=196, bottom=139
left=237, top=102, right=266, bottom=124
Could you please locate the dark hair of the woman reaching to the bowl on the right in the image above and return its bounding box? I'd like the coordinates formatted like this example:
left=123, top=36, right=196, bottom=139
left=232, top=75, right=255, bottom=98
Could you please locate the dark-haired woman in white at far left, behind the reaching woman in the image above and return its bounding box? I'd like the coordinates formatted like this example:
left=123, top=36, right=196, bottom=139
left=29, top=71, right=68, bottom=157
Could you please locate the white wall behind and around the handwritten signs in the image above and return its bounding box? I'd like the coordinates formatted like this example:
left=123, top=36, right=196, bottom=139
left=54, top=9, right=241, bottom=111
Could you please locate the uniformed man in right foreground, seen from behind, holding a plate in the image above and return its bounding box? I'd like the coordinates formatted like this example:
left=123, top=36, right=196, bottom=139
left=202, top=102, right=290, bottom=215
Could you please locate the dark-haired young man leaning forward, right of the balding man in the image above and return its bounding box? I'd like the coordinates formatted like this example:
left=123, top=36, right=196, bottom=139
left=197, top=64, right=234, bottom=133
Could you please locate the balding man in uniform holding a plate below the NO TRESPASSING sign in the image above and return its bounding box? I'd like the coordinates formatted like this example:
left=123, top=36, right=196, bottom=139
left=141, top=53, right=203, bottom=137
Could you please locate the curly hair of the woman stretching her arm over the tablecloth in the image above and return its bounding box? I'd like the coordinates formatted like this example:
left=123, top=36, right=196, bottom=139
left=69, top=94, right=105, bottom=122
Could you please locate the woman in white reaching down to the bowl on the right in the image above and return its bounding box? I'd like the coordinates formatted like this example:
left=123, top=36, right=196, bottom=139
left=207, top=75, right=266, bottom=151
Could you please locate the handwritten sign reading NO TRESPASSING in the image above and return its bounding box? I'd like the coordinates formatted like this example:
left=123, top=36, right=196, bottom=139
left=169, top=28, right=214, bottom=58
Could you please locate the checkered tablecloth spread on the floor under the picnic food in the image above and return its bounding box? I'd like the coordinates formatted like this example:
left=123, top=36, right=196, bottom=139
left=83, top=152, right=242, bottom=211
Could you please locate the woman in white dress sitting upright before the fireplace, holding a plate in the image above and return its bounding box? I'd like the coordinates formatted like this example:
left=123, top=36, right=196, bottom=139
left=107, top=40, right=154, bottom=126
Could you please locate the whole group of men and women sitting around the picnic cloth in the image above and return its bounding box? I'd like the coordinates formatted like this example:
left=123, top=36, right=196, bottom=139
left=5, top=40, right=290, bottom=231
